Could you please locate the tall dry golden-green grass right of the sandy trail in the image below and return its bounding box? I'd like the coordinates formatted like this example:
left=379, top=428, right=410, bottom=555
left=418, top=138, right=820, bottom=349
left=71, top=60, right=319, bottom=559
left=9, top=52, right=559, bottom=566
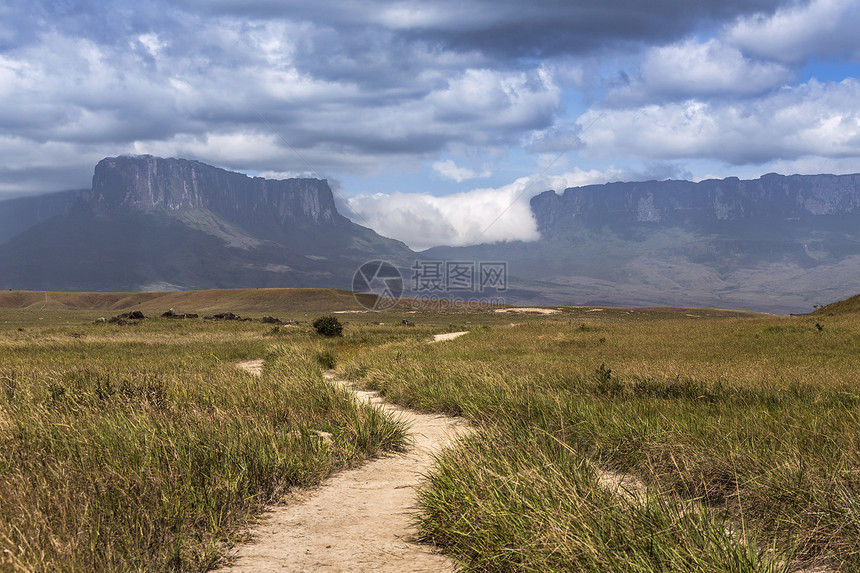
left=343, top=314, right=860, bottom=571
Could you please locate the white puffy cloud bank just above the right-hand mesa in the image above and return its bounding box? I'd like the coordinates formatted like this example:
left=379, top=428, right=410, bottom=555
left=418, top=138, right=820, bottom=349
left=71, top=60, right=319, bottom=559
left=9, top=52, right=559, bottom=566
left=578, top=79, right=860, bottom=165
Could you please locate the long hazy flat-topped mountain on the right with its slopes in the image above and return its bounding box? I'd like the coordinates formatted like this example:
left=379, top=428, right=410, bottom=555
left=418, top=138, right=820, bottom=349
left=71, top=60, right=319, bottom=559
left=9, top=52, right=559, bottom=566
left=422, top=174, right=860, bottom=312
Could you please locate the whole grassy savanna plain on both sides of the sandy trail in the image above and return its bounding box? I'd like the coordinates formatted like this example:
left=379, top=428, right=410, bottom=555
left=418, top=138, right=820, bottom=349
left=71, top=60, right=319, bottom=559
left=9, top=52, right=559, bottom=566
left=0, top=290, right=860, bottom=572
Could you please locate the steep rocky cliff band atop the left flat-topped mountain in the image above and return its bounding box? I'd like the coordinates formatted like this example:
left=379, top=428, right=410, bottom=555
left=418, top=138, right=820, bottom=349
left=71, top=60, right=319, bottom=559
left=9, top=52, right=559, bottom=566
left=85, top=155, right=347, bottom=228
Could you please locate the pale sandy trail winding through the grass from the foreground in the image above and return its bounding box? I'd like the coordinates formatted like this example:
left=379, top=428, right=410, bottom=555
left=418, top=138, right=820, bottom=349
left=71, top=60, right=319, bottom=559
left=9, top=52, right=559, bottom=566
left=221, top=361, right=466, bottom=573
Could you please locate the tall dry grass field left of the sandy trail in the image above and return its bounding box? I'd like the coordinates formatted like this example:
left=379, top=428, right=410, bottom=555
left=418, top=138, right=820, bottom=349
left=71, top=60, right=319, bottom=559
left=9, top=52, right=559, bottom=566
left=0, top=320, right=405, bottom=571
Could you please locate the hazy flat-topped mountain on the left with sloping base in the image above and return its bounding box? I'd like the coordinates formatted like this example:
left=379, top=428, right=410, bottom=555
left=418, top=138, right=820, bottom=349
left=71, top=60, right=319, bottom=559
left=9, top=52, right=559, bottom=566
left=0, top=156, right=413, bottom=292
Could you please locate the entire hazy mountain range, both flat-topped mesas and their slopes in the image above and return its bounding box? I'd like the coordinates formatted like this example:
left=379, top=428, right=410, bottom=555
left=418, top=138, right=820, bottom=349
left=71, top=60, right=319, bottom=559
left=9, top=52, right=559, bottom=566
left=0, top=156, right=860, bottom=312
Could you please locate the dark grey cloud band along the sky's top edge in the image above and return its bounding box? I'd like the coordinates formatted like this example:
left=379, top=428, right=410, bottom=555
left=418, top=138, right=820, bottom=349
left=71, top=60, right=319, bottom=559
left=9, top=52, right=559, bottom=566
left=184, top=0, right=784, bottom=58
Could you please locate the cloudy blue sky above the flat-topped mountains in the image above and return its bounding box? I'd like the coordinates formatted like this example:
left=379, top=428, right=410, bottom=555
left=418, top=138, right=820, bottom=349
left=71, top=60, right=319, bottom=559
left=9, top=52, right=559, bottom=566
left=0, top=0, right=860, bottom=249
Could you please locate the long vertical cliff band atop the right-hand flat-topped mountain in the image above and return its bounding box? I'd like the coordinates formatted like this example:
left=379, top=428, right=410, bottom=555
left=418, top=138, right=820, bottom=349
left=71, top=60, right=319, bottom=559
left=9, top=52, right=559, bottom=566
left=531, top=174, right=860, bottom=236
